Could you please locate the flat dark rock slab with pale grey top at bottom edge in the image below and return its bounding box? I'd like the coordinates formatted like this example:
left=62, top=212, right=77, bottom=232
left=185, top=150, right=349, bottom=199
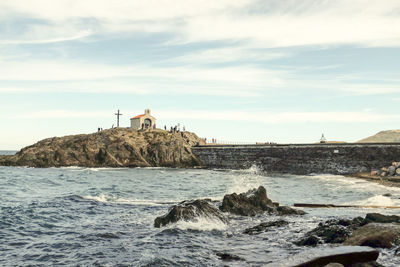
left=272, top=246, right=379, bottom=267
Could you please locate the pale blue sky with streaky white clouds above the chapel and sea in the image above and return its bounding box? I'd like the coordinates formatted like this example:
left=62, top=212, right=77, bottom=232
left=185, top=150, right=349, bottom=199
left=0, top=0, right=400, bottom=150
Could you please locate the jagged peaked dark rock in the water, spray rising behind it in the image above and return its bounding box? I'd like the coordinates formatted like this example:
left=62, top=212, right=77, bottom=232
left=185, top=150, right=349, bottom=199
left=220, top=186, right=276, bottom=216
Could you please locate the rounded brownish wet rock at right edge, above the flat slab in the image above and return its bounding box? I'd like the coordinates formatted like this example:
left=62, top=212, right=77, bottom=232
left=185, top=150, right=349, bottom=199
left=344, top=223, right=400, bottom=248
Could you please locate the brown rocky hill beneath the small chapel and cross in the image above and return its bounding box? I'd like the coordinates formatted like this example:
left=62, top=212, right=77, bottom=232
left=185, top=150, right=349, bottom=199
left=0, top=128, right=202, bottom=167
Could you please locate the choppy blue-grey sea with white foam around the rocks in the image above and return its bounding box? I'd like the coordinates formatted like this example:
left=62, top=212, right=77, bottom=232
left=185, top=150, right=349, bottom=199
left=0, top=152, right=400, bottom=266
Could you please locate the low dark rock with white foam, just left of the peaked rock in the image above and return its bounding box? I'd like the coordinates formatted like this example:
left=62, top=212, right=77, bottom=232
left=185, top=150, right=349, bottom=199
left=154, top=199, right=228, bottom=228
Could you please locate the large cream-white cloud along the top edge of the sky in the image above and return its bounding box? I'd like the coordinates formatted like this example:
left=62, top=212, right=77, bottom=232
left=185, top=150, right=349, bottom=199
left=0, top=0, right=400, bottom=48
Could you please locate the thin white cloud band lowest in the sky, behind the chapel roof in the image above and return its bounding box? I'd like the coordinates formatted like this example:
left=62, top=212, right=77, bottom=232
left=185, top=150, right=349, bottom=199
left=16, top=110, right=400, bottom=124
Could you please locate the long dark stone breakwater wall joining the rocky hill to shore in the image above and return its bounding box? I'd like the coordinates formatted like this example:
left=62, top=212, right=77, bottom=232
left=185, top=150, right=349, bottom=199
left=192, top=143, right=400, bottom=174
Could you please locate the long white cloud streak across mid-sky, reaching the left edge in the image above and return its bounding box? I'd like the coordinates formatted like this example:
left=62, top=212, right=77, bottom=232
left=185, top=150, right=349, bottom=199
left=0, top=60, right=285, bottom=96
